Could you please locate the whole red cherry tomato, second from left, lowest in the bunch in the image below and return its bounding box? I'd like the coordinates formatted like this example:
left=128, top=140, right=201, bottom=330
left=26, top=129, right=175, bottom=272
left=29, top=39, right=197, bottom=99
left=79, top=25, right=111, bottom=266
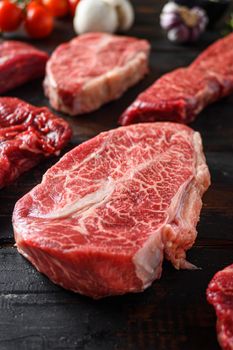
left=24, top=1, right=54, bottom=39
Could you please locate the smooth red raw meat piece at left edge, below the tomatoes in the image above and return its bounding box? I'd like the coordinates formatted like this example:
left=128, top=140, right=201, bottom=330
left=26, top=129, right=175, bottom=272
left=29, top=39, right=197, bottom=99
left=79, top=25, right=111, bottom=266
left=0, top=41, right=48, bottom=94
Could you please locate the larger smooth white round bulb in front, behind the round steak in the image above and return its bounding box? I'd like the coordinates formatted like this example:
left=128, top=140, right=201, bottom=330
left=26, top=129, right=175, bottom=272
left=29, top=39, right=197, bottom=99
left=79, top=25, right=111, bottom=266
left=73, top=0, right=118, bottom=34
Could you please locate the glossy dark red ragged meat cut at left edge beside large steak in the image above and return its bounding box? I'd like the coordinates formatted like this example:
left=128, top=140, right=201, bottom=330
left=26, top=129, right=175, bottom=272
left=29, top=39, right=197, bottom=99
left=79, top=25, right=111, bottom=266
left=0, top=97, right=71, bottom=188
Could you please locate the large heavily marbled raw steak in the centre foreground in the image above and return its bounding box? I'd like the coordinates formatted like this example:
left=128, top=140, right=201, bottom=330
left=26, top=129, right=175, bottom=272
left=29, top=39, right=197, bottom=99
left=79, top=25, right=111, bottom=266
left=13, top=123, right=210, bottom=298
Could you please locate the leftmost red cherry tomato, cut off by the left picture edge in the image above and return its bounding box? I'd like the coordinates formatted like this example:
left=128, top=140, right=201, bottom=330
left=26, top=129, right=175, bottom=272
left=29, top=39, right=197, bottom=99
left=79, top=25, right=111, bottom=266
left=0, top=0, right=23, bottom=32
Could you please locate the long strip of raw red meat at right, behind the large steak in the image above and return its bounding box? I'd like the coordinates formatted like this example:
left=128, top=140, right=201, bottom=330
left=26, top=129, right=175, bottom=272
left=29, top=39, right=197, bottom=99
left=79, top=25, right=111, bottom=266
left=119, top=34, right=233, bottom=125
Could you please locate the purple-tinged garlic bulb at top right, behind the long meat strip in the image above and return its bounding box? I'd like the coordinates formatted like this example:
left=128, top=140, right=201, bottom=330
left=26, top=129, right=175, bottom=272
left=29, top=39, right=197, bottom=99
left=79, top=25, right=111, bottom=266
left=160, top=1, right=208, bottom=43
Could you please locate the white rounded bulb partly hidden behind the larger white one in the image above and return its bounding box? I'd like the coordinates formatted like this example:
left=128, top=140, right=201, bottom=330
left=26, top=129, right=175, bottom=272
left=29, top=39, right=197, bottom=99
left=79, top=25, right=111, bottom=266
left=102, top=0, right=135, bottom=31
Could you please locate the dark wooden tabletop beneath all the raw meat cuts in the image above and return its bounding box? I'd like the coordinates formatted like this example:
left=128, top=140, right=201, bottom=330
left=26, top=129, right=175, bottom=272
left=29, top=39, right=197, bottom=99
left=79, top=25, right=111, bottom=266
left=0, top=0, right=233, bottom=350
